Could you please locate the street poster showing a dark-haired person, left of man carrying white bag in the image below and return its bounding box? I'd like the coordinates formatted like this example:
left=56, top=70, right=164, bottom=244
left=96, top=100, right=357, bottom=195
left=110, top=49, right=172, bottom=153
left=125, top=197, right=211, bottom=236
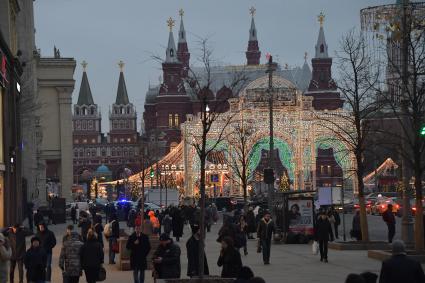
left=288, top=199, right=314, bottom=235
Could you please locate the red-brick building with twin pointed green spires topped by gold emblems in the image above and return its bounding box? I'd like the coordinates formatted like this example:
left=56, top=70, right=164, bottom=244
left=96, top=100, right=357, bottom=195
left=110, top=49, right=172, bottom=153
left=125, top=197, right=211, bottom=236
left=72, top=62, right=141, bottom=184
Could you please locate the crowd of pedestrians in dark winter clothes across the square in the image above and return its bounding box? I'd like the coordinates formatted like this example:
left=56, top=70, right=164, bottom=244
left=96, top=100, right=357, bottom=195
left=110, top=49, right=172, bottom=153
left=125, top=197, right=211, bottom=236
left=0, top=201, right=425, bottom=283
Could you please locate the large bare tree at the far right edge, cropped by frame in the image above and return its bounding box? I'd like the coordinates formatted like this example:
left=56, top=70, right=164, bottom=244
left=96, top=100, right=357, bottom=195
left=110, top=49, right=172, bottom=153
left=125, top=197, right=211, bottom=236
left=379, top=1, right=425, bottom=251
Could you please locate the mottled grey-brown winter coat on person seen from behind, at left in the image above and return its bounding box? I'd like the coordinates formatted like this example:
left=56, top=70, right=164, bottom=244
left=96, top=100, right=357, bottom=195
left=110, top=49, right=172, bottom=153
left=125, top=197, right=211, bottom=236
left=59, top=232, right=83, bottom=276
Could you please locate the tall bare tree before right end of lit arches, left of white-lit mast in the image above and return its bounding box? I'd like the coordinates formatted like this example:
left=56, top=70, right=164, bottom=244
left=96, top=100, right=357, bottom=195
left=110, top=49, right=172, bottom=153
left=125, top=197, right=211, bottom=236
left=321, top=29, right=378, bottom=242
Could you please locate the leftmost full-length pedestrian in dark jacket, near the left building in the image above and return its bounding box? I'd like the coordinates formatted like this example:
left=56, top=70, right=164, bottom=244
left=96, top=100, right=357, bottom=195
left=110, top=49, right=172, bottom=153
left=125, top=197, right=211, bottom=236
left=7, top=224, right=32, bottom=283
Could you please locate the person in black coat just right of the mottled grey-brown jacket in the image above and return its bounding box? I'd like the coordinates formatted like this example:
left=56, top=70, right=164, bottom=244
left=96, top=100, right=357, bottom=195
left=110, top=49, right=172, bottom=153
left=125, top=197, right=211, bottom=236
left=80, top=229, right=104, bottom=283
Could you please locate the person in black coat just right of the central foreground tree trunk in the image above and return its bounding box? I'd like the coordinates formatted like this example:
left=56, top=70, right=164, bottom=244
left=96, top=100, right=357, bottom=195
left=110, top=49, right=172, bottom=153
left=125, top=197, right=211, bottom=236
left=217, top=237, right=242, bottom=278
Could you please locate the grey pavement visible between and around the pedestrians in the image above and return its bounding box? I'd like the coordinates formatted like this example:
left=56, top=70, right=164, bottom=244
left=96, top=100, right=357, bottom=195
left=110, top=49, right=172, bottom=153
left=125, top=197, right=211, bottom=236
left=28, top=220, right=380, bottom=283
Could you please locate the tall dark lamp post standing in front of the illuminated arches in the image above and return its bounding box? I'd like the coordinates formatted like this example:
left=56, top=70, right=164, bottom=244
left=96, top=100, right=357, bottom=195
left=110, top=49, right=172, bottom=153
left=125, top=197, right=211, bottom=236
left=266, top=55, right=276, bottom=209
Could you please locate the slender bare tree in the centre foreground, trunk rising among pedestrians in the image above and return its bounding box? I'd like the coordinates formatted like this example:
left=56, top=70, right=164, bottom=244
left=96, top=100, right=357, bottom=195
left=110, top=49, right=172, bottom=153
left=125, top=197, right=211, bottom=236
left=186, top=39, right=247, bottom=277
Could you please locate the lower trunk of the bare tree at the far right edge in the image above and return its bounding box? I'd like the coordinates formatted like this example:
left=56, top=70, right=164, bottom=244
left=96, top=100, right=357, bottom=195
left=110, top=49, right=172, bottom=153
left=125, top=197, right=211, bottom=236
left=415, top=165, right=424, bottom=252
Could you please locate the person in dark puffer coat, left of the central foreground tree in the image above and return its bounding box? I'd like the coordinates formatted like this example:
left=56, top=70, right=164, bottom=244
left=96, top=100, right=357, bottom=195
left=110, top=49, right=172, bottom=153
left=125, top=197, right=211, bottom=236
left=153, top=233, right=181, bottom=279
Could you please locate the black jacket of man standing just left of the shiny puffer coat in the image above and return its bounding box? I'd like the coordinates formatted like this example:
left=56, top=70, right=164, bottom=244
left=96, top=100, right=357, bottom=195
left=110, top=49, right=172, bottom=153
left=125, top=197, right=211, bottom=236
left=126, top=232, right=151, bottom=270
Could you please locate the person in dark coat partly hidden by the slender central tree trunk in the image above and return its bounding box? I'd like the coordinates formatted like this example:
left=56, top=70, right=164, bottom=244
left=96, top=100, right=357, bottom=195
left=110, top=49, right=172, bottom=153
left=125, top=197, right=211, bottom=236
left=186, top=225, right=210, bottom=277
